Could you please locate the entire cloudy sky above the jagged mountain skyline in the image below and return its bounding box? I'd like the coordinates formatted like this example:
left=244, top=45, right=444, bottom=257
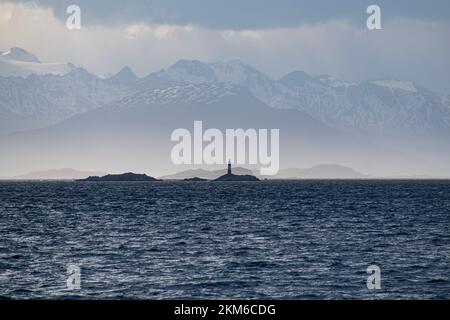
left=0, top=0, right=450, bottom=94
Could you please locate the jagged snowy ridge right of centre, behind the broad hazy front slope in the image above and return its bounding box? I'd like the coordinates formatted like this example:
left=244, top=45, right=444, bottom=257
left=152, top=60, right=450, bottom=135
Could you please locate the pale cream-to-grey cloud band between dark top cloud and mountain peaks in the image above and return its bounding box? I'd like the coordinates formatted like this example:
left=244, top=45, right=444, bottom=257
left=0, top=2, right=450, bottom=93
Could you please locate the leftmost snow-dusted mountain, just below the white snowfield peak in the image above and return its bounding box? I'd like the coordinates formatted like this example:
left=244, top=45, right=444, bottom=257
left=0, top=68, right=129, bottom=134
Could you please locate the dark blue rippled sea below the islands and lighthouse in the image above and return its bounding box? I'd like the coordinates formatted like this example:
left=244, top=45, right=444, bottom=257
left=0, top=181, right=450, bottom=299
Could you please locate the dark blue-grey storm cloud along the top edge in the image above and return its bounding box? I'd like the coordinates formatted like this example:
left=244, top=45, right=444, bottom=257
left=15, top=0, right=450, bottom=29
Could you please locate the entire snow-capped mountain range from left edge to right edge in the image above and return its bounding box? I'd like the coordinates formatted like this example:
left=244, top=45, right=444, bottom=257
left=0, top=48, right=450, bottom=137
